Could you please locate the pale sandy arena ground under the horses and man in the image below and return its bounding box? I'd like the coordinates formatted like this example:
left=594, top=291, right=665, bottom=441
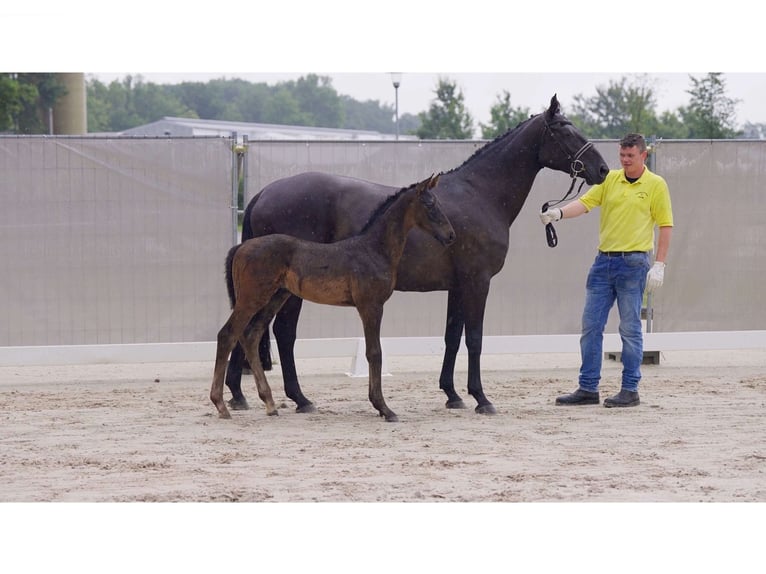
left=0, top=350, right=766, bottom=502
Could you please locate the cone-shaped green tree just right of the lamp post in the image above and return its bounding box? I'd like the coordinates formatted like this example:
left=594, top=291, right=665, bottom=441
left=416, top=78, right=473, bottom=140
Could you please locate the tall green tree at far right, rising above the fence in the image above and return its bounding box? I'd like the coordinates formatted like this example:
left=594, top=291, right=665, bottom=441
left=679, top=72, right=740, bottom=139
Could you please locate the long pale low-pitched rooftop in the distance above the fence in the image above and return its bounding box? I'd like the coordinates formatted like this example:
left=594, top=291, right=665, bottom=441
left=120, top=117, right=418, bottom=141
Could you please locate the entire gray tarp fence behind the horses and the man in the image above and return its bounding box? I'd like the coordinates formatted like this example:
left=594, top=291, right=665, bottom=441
left=0, top=136, right=766, bottom=356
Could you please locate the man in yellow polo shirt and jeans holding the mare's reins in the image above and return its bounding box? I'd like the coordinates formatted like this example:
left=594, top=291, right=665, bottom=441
left=540, top=134, right=673, bottom=407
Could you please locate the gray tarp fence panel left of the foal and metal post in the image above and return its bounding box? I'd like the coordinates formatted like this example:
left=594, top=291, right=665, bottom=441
left=0, top=137, right=232, bottom=346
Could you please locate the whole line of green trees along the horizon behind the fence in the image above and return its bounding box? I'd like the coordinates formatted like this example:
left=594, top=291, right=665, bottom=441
left=0, top=72, right=766, bottom=139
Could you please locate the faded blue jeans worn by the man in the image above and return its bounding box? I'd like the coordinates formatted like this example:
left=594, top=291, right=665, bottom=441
left=579, top=253, right=649, bottom=392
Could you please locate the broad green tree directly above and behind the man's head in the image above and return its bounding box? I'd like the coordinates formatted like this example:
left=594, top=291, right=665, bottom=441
left=569, top=74, right=658, bottom=138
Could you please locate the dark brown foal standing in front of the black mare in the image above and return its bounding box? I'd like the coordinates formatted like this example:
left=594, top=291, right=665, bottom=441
left=210, top=175, right=455, bottom=421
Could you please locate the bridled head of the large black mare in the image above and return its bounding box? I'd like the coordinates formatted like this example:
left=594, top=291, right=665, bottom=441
left=538, top=94, right=609, bottom=185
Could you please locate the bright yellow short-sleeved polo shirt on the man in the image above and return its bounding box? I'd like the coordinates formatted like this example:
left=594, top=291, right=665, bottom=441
left=578, top=168, right=673, bottom=251
